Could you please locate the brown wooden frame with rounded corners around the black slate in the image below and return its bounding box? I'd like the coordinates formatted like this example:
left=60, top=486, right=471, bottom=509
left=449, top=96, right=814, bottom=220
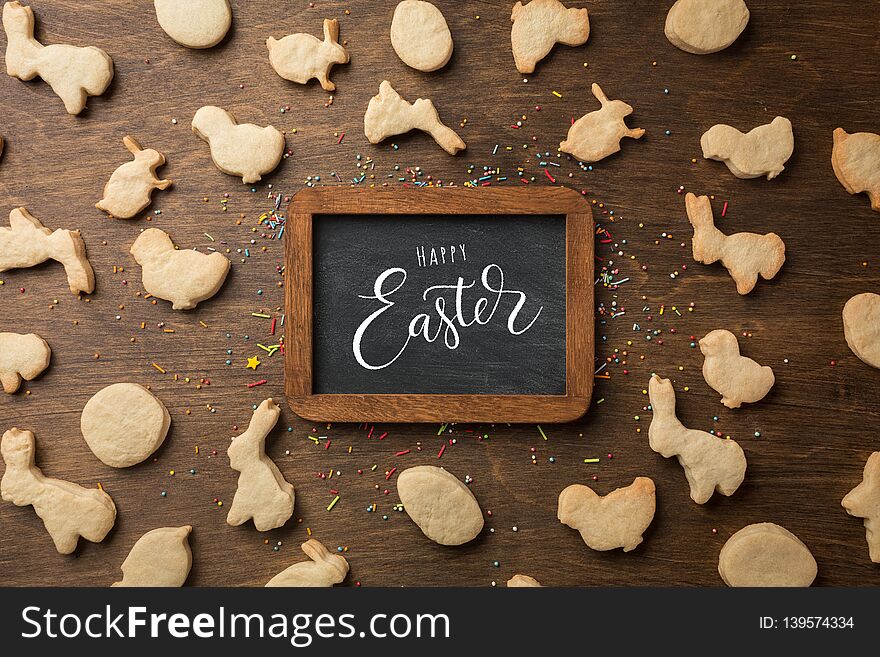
left=284, top=186, right=595, bottom=423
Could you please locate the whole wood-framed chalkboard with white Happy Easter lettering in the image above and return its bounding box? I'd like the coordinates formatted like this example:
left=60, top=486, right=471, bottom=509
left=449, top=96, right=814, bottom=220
left=285, top=188, right=593, bottom=422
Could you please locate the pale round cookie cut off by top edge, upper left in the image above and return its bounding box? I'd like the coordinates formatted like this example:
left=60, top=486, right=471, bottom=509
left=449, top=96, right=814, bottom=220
left=153, top=0, right=232, bottom=49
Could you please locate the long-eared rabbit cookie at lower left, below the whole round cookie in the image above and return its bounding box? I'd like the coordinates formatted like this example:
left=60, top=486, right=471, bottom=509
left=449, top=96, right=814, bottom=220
left=0, top=429, right=116, bottom=554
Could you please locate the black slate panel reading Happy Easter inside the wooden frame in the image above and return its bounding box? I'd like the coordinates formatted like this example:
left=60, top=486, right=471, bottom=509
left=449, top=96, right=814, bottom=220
left=312, top=215, right=566, bottom=395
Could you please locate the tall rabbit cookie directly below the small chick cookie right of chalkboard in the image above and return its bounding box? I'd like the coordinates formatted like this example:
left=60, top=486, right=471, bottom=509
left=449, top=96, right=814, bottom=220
left=648, top=374, right=746, bottom=504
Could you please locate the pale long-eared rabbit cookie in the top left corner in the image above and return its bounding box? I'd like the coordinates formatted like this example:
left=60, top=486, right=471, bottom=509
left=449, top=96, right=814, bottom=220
left=3, top=2, right=113, bottom=114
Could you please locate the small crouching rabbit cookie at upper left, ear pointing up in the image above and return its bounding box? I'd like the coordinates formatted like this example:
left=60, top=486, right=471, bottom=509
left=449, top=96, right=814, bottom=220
left=95, top=135, right=172, bottom=219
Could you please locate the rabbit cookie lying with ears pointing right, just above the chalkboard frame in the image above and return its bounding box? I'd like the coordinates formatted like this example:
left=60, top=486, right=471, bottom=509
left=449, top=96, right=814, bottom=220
left=364, top=80, right=466, bottom=155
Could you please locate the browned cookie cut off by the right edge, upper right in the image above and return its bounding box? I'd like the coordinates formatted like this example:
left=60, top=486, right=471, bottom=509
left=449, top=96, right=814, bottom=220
left=831, top=128, right=880, bottom=212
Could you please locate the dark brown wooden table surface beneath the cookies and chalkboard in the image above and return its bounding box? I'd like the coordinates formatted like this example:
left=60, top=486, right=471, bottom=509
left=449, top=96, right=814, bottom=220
left=0, top=0, right=880, bottom=586
